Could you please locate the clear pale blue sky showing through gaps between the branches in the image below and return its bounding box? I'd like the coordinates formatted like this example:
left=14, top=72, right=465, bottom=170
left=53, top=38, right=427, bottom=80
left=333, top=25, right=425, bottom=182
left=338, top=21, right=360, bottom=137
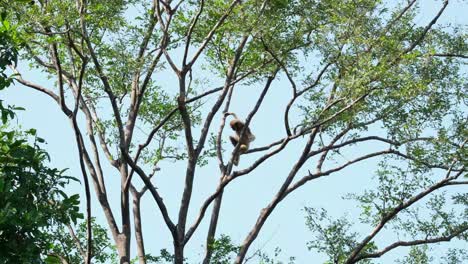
left=1, top=1, right=468, bottom=263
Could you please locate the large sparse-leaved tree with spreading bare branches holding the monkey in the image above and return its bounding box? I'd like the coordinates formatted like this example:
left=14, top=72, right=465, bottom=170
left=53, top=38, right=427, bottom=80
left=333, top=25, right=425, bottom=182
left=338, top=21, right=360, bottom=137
left=3, top=0, right=468, bottom=263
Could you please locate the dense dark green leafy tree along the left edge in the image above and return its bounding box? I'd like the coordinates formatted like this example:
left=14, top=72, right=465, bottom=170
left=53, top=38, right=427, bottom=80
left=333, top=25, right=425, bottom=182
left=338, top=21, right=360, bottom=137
left=0, top=14, right=82, bottom=263
